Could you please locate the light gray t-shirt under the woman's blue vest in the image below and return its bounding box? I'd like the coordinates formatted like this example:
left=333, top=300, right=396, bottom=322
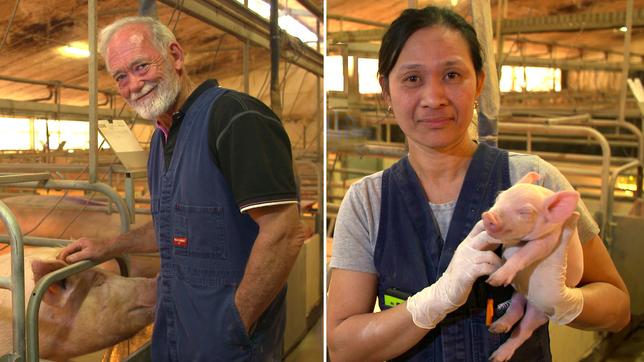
left=331, top=152, right=599, bottom=274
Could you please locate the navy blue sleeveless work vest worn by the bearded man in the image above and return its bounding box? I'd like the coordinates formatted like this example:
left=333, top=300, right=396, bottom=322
left=148, top=87, right=286, bottom=362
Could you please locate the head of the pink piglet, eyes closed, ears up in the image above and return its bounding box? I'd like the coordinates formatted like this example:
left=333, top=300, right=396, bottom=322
left=482, top=172, right=579, bottom=245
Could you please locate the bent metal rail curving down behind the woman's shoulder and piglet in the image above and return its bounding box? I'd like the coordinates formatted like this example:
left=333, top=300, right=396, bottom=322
left=499, top=122, right=611, bottom=238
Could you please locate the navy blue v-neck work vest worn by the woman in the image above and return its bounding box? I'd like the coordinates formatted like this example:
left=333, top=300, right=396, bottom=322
left=374, top=144, right=552, bottom=362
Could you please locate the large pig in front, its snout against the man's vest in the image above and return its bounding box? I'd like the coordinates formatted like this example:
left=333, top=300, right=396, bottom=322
left=0, top=247, right=156, bottom=361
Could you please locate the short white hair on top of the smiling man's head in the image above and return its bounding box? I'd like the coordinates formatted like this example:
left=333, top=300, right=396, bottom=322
left=98, top=16, right=177, bottom=59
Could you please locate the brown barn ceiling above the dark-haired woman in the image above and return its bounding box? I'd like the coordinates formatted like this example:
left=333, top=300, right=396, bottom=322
left=327, top=0, right=644, bottom=62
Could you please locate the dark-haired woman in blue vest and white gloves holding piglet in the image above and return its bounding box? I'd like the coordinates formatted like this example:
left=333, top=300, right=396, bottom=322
left=327, top=7, right=630, bottom=361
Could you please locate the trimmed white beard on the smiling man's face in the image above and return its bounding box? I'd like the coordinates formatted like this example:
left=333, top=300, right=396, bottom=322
left=127, top=69, right=181, bottom=120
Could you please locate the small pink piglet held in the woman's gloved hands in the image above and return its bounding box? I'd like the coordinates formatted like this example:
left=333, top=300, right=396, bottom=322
left=482, top=172, right=583, bottom=361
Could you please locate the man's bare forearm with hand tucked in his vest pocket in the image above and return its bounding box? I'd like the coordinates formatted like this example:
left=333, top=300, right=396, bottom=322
left=235, top=206, right=304, bottom=330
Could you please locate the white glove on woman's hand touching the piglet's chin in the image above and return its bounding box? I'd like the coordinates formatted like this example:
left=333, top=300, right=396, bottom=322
left=407, top=221, right=502, bottom=329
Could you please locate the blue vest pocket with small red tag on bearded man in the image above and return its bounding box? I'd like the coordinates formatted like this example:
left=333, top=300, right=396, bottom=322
left=170, top=203, right=228, bottom=260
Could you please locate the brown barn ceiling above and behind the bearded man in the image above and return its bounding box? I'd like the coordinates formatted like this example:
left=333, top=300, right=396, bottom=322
left=0, top=0, right=322, bottom=120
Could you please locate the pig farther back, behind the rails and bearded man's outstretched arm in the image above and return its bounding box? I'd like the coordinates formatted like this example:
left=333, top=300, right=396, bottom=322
left=0, top=195, right=160, bottom=278
